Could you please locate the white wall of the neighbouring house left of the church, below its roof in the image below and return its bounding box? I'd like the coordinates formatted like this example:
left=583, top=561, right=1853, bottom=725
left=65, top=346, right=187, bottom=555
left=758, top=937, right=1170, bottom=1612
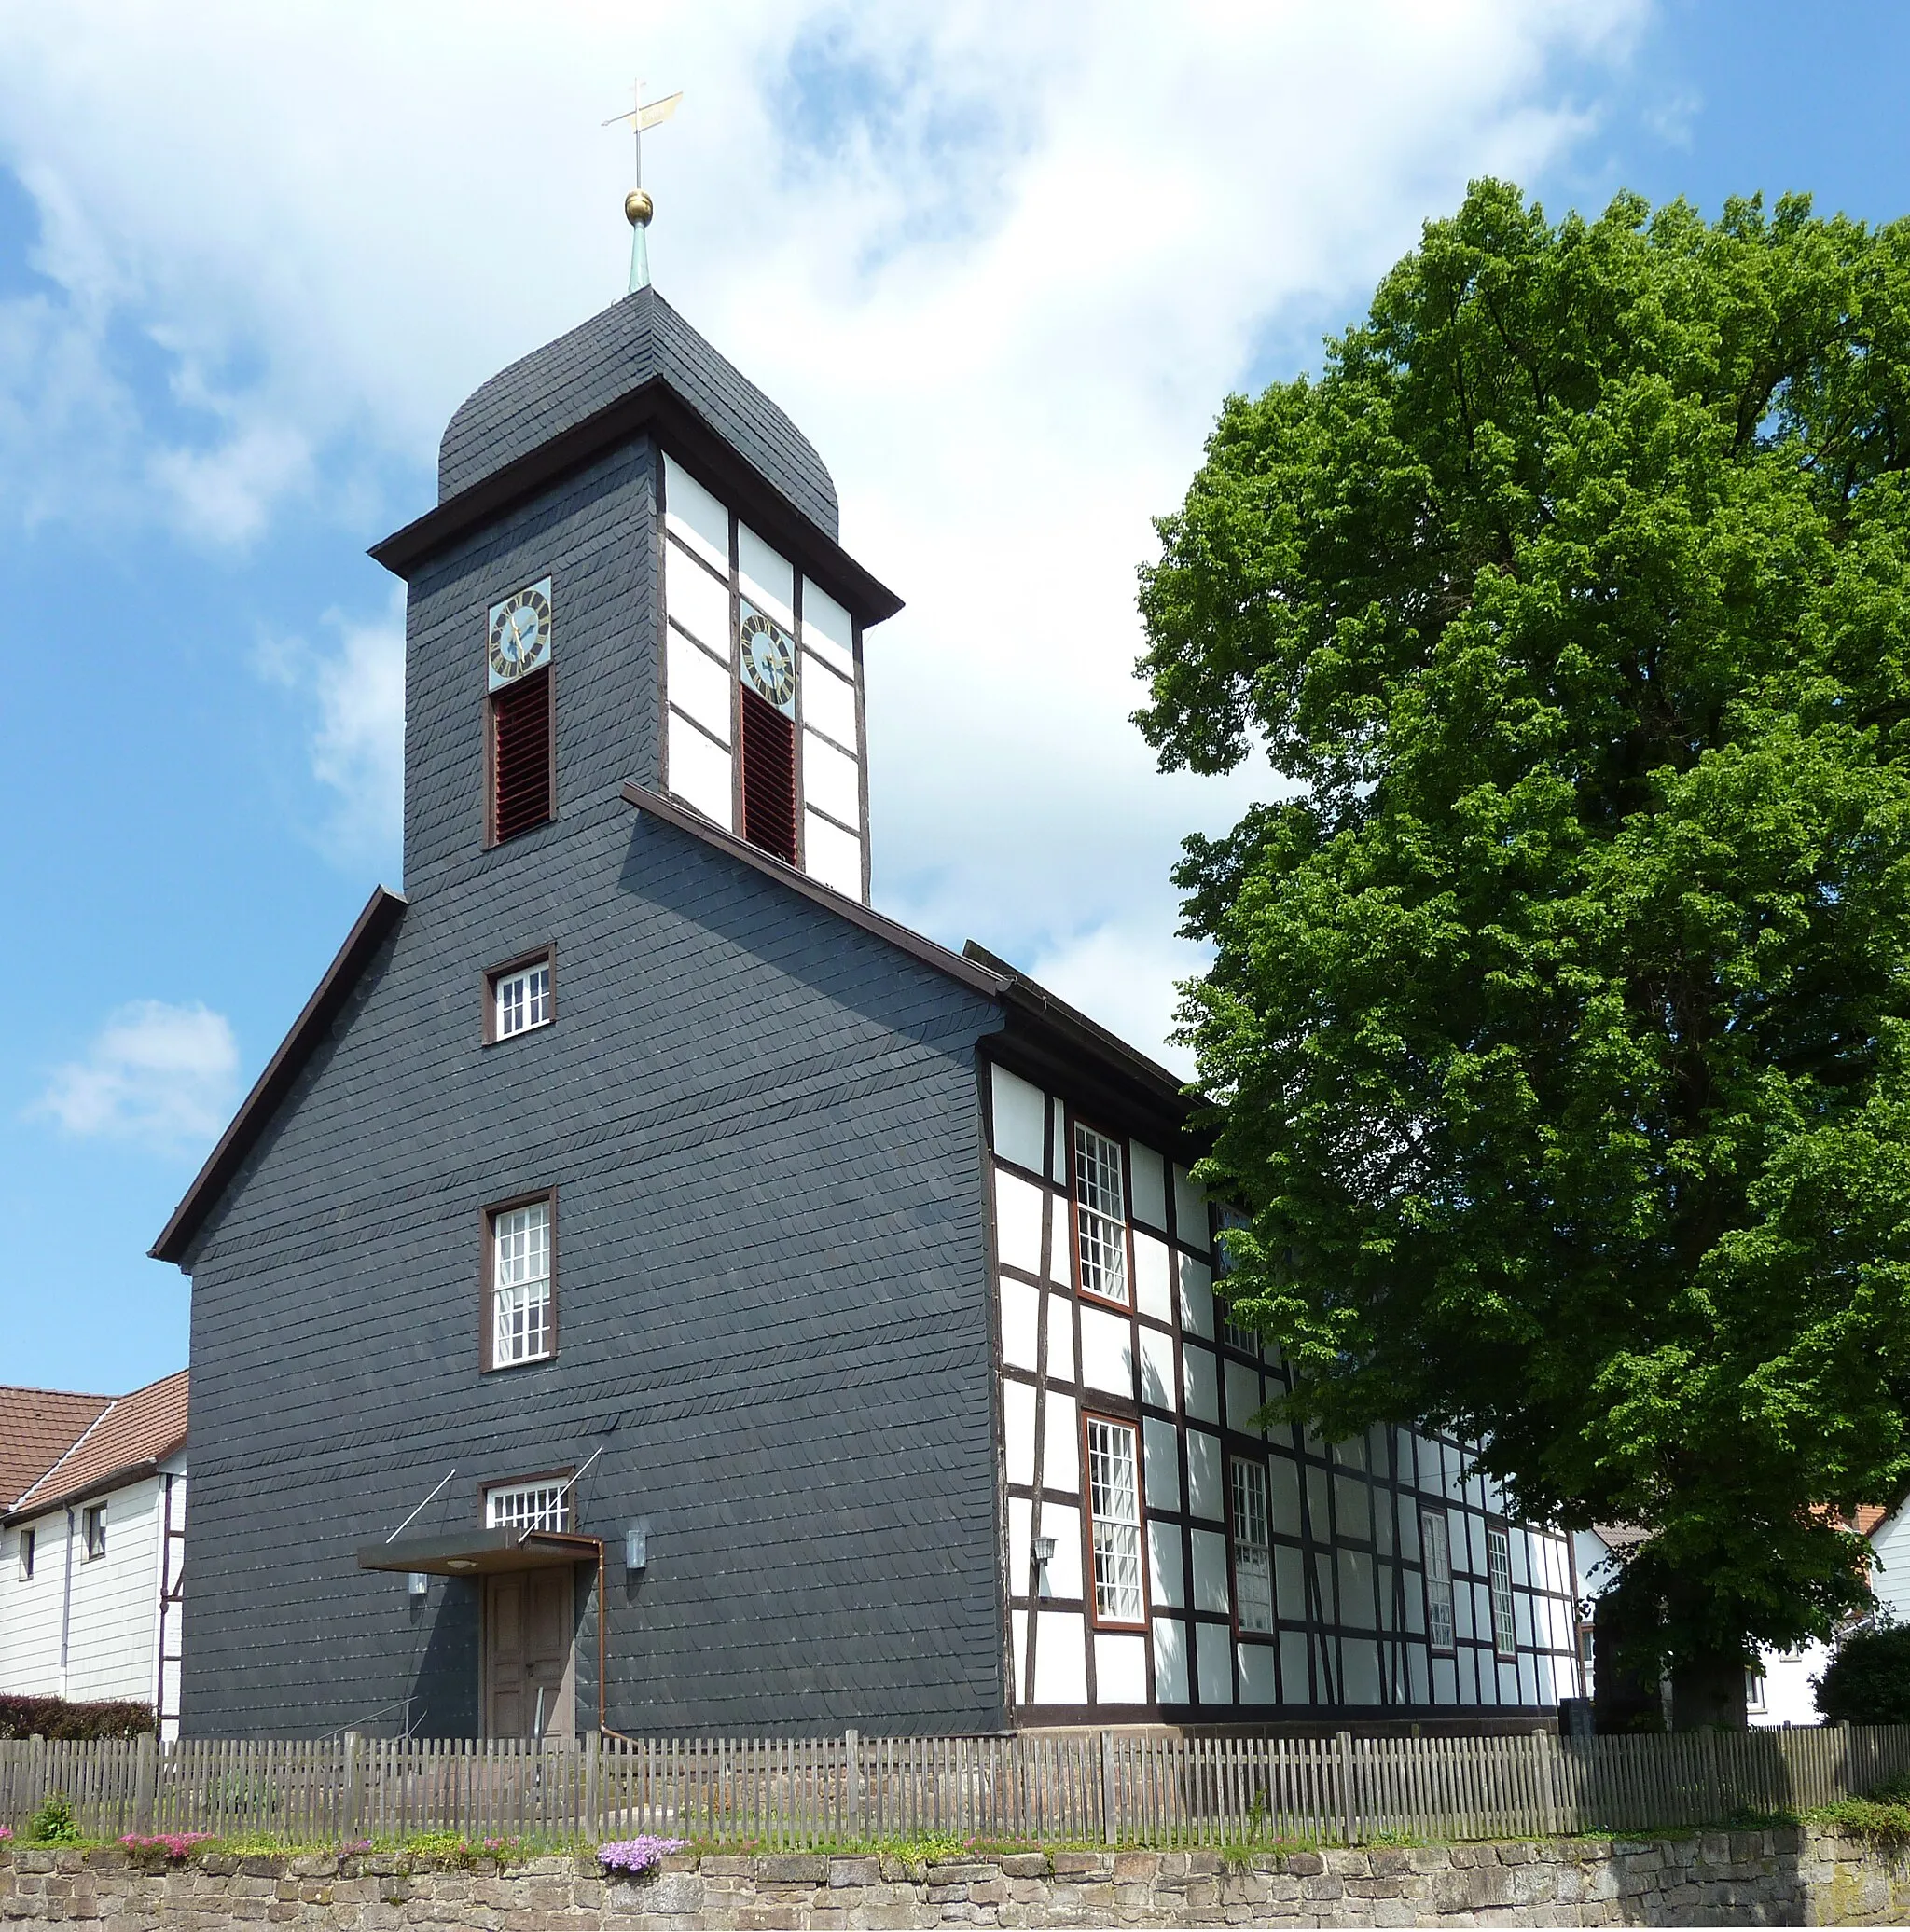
left=0, top=1456, right=186, bottom=1737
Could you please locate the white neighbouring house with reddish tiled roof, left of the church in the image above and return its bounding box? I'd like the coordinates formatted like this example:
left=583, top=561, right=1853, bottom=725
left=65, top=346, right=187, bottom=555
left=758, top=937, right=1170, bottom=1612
left=0, top=1370, right=186, bottom=1739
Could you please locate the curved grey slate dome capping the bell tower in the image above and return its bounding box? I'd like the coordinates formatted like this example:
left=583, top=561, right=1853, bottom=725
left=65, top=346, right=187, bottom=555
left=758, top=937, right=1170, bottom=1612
left=436, top=288, right=839, bottom=539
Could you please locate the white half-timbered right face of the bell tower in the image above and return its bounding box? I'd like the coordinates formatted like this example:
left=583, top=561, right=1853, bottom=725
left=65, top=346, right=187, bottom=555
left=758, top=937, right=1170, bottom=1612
left=663, top=456, right=868, bottom=904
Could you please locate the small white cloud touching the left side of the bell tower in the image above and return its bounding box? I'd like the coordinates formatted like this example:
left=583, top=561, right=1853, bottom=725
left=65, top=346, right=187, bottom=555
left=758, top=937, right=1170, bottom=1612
left=257, top=591, right=404, bottom=865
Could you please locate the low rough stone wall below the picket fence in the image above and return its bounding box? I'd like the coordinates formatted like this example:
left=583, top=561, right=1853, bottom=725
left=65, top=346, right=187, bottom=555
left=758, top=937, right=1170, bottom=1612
left=0, top=1831, right=1910, bottom=1932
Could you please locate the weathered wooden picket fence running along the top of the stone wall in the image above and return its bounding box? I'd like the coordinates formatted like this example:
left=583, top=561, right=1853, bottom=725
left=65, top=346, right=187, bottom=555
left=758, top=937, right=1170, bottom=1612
left=0, top=1725, right=1910, bottom=1851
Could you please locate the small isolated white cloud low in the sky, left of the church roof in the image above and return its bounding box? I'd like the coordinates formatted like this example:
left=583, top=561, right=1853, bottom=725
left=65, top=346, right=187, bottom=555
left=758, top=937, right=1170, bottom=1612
left=31, top=999, right=238, bottom=1153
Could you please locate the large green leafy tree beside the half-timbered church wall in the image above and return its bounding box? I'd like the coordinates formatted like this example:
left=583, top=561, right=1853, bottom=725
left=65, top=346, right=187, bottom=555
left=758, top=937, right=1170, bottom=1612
left=1137, top=182, right=1910, bottom=1723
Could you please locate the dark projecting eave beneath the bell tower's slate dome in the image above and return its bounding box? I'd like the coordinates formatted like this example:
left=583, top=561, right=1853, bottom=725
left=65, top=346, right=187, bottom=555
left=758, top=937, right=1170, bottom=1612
left=369, top=375, right=903, bottom=624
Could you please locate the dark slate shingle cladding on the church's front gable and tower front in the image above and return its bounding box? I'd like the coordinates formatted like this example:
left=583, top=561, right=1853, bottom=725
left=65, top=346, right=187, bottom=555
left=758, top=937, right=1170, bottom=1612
left=184, top=377, right=1005, bottom=1737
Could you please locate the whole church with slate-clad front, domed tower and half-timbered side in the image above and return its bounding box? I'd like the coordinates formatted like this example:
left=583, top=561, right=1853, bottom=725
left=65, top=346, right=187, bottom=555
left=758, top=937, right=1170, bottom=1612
left=153, top=249, right=1577, bottom=1737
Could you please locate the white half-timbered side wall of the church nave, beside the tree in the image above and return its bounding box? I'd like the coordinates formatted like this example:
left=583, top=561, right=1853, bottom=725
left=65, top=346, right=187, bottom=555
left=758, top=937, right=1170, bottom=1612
left=986, top=1067, right=1577, bottom=1721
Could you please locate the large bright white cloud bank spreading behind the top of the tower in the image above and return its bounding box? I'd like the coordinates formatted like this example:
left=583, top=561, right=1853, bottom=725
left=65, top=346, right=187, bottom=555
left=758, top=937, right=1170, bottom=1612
left=0, top=0, right=1647, bottom=1049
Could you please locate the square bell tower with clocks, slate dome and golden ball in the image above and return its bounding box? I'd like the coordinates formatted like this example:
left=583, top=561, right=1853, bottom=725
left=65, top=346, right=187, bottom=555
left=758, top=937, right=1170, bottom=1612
left=371, top=189, right=901, bottom=904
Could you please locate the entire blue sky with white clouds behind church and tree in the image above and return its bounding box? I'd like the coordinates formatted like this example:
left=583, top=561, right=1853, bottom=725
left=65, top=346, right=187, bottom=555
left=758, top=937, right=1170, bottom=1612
left=0, top=0, right=1910, bottom=1391
